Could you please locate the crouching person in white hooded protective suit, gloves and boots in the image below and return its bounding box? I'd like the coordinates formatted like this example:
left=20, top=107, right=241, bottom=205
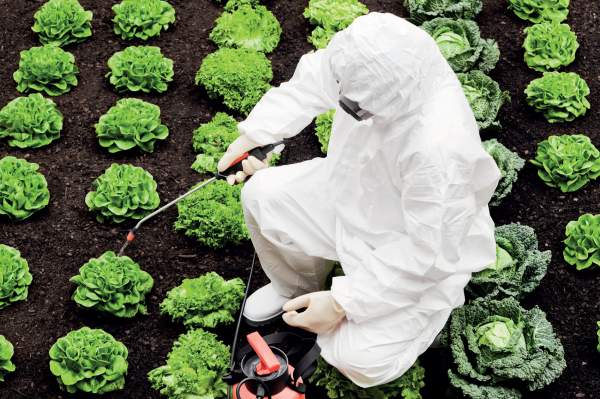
left=218, top=13, right=500, bottom=387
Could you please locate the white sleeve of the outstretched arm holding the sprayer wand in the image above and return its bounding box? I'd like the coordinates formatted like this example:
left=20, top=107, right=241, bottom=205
left=238, top=49, right=339, bottom=145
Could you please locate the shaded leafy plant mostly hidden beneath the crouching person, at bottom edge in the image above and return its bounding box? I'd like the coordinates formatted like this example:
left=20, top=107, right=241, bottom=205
left=309, top=356, right=425, bottom=399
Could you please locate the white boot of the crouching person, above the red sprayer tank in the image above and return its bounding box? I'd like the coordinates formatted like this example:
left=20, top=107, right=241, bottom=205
left=244, top=284, right=291, bottom=327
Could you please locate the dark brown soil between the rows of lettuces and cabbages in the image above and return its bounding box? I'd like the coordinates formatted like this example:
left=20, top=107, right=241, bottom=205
left=0, top=0, right=600, bottom=399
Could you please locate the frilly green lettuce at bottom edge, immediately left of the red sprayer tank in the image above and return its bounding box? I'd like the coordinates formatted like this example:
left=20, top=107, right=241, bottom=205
left=148, top=328, right=231, bottom=399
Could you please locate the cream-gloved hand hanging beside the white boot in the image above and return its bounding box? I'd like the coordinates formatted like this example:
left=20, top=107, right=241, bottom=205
left=283, top=291, right=346, bottom=334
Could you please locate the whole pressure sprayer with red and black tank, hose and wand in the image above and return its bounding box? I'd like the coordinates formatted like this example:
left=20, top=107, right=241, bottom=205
left=118, top=140, right=321, bottom=399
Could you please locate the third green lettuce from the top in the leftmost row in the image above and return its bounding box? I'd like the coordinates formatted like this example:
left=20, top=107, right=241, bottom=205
left=0, top=93, right=63, bottom=148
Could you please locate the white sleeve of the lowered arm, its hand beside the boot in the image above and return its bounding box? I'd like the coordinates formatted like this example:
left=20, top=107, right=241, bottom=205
left=332, top=145, right=500, bottom=323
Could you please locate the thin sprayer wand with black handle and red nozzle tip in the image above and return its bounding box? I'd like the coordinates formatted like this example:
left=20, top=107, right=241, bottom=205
left=117, top=140, right=290, bottom=256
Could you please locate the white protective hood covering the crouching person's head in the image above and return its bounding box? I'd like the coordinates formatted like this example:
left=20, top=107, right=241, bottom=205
left=327, top=13, right=452, bottom=123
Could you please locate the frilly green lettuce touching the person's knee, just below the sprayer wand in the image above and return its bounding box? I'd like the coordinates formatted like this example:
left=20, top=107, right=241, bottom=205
left=174, top=180, right=250, bottom=249
